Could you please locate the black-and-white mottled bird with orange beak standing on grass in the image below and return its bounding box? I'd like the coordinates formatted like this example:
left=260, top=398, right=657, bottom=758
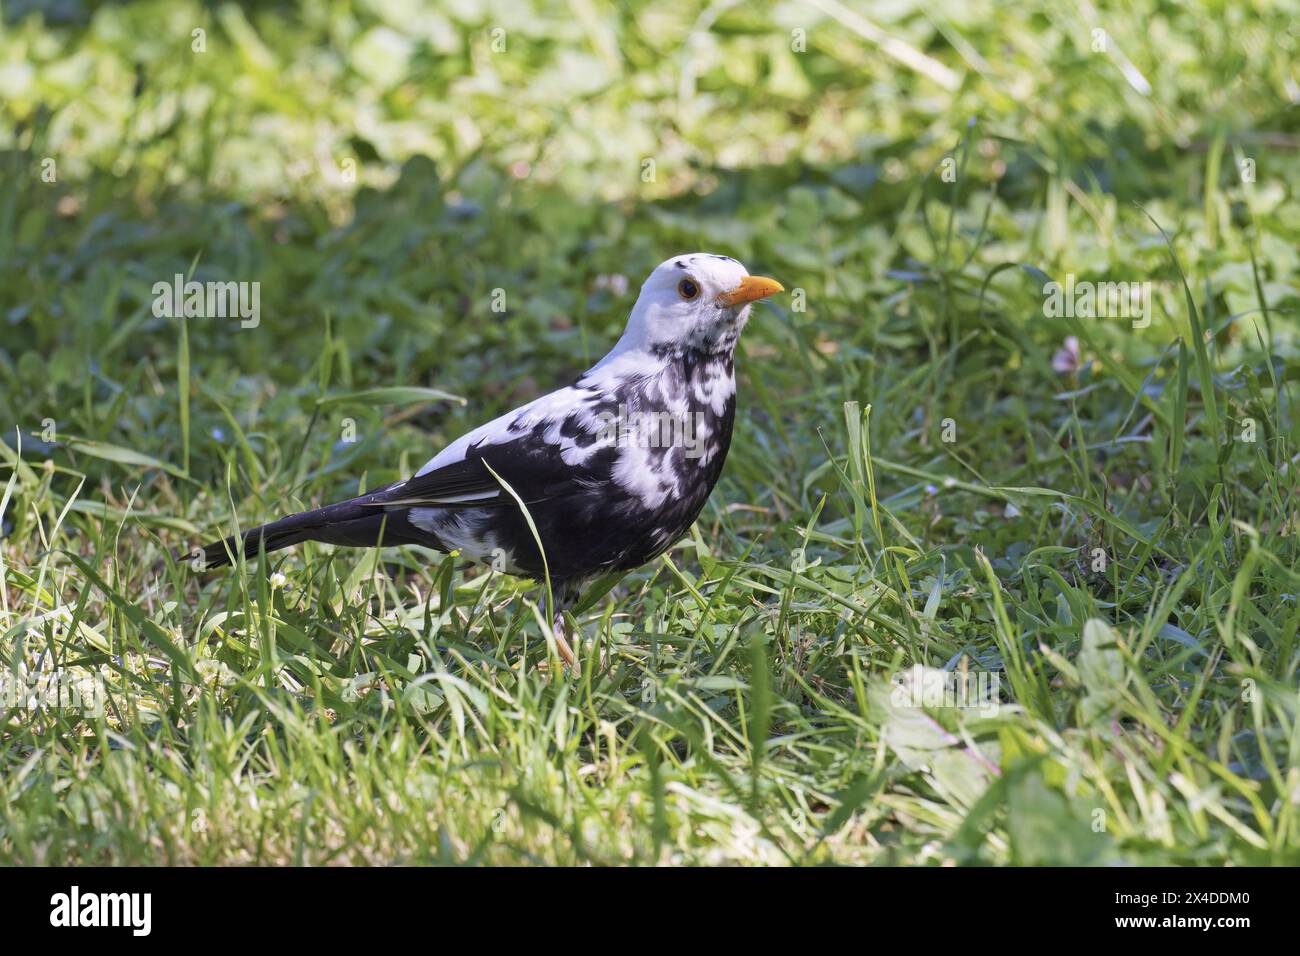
left=187, top=252, right=784, bottom=665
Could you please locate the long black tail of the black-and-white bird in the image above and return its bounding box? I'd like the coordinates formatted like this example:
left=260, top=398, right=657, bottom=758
left=190, top=494, right=426, bottom=570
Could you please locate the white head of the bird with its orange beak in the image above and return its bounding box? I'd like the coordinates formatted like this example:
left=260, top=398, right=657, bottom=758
left=615, top=252, right=784, bottom=355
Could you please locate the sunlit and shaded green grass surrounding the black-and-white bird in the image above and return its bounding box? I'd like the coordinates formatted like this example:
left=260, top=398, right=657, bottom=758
left=0, top=0, right=1300, bottom=865
